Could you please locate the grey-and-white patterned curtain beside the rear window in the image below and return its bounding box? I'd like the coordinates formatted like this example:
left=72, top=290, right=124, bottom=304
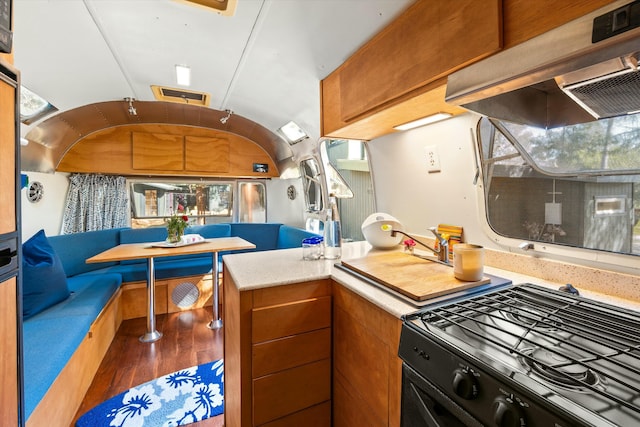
left=62, top=174, right=128, bottom=234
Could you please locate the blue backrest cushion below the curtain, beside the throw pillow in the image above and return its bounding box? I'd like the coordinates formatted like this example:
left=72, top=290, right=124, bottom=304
left=49, top=228, right=121, bottom=277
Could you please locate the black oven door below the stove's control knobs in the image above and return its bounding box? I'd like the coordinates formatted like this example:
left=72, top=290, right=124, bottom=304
left=400, top=363, right=483, bottom=427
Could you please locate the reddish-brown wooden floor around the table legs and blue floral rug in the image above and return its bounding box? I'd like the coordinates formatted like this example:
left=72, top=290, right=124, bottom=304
left=72, top=308, right=224, bottom=427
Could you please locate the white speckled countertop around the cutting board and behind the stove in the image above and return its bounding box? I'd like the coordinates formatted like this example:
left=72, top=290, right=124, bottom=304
left=223, top=242, right=640, bottom=318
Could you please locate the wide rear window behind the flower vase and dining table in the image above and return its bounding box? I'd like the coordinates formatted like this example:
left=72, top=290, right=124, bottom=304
left=130, top=181, right=234, bottom=228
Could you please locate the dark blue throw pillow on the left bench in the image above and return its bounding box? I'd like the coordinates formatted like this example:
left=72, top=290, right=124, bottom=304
left=22, top=230, right=69, bottom=319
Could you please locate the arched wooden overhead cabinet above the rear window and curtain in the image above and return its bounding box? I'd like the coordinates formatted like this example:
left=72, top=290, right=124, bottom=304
left=56, top=124, right=280, bottom=178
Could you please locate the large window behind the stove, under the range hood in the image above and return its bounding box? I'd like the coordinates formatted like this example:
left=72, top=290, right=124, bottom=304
left=478, top=114, right=640, bottom=255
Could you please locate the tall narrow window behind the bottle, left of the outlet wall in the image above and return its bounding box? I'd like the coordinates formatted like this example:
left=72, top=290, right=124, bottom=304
left=320, top=140, right=375, bottom=241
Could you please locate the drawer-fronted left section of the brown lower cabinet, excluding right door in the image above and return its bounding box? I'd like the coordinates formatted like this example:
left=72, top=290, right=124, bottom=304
left=223, top=274, right=331, bottom=427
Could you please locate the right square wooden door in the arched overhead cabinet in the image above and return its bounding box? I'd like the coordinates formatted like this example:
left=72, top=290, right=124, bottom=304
left=184, top=136, right=230, bottom=172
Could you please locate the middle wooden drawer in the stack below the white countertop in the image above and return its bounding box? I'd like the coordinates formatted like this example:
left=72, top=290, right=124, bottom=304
left=252, top=328, right=331, bottom=378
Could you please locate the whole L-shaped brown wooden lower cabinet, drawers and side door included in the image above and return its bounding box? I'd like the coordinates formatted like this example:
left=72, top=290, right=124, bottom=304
left=223, top=274, right=401, bottom=427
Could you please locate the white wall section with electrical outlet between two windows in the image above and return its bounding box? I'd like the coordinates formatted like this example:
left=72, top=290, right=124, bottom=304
left=368, top=114, right=493, bottom=247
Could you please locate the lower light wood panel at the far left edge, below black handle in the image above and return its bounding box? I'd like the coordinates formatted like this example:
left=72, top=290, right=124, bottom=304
left=0, top=277, right=19, bottom=426
